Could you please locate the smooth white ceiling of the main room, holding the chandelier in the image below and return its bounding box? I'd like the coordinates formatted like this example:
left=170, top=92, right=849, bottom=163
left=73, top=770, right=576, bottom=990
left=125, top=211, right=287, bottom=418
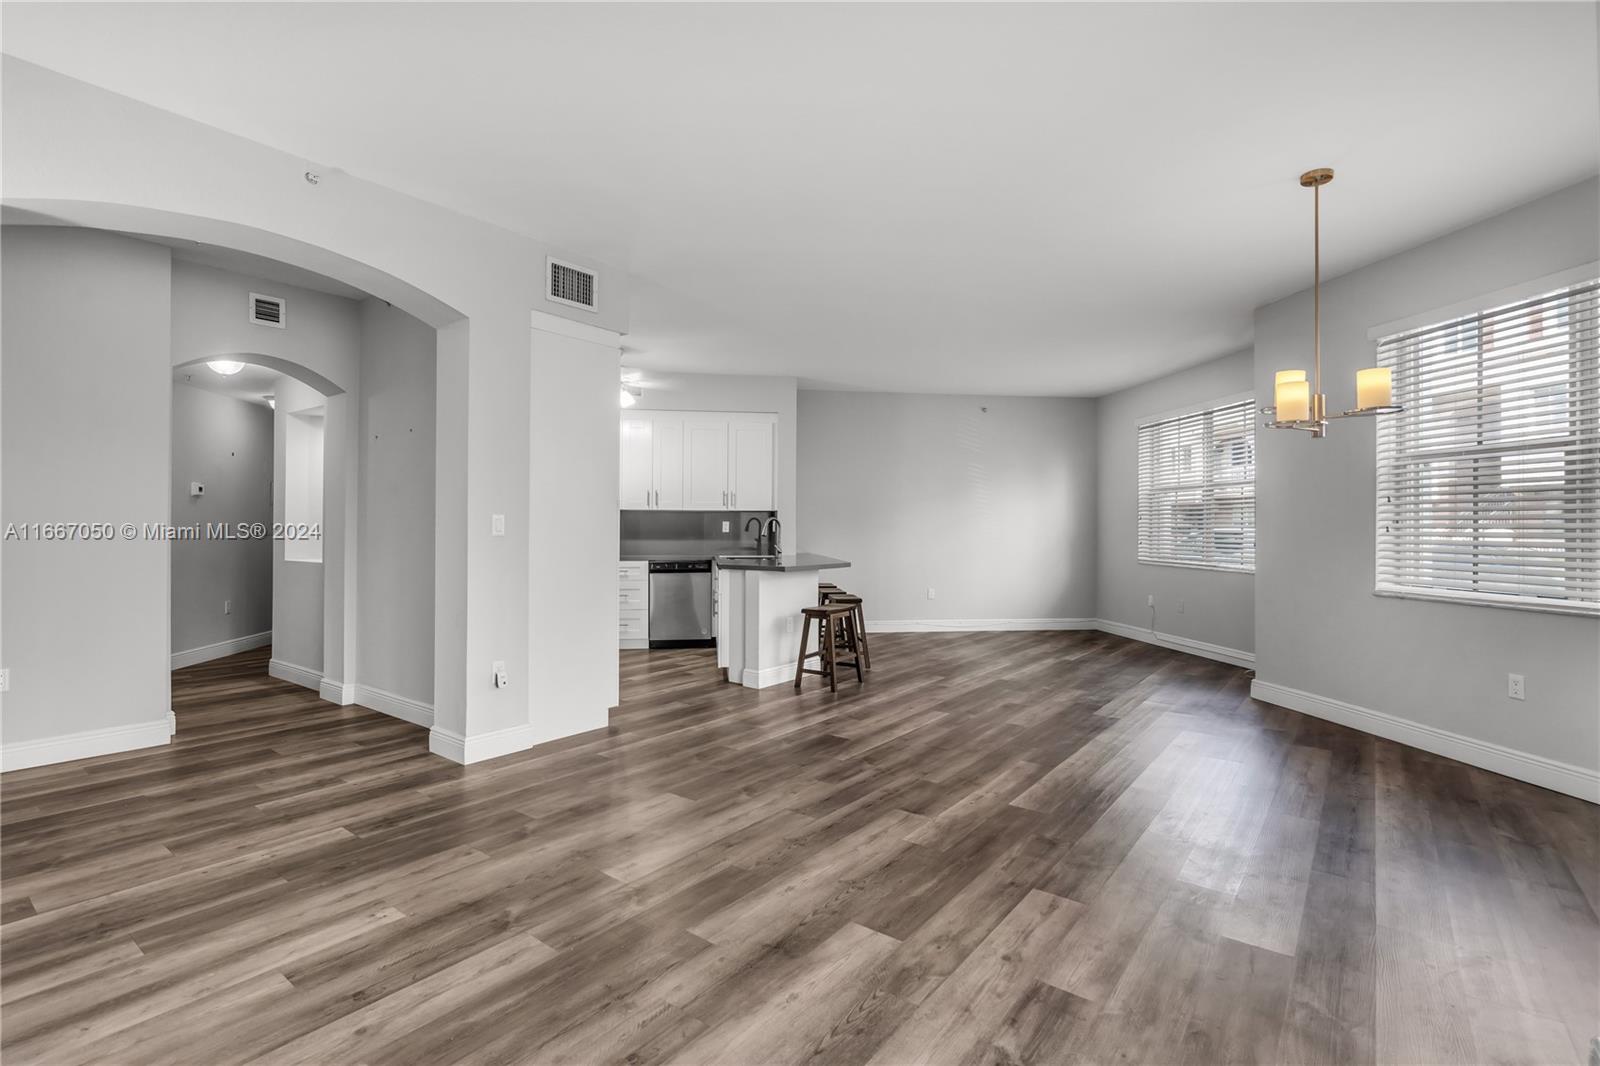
left=3, top=3, right=1600, bottom=395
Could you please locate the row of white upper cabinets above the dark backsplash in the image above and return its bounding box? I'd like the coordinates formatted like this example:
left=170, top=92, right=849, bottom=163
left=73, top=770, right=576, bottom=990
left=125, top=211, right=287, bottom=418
left=618, top=411, right=778, bottom=511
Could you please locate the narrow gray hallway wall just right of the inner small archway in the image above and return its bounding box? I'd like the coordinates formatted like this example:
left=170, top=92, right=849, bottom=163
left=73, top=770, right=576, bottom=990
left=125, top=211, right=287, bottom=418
left=355, top=299, right=437, bottom=704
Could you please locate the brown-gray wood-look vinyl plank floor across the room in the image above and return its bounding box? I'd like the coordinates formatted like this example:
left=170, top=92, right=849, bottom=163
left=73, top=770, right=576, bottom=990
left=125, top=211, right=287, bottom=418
left=0, top=632, right=1600, bottom=1066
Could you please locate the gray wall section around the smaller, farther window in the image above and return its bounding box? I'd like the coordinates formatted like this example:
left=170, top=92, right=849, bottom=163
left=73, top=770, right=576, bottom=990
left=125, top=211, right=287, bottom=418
left=1096, top=351, right=1256, bottom=651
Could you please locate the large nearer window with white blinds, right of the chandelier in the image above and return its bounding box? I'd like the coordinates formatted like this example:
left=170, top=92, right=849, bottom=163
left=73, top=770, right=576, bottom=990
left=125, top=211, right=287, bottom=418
left=1376, top=282, right=1600, bottom=615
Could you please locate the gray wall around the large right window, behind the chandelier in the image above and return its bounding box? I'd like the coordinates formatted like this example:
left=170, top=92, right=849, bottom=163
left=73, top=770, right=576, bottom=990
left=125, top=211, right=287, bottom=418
left=1254, top=181, right=1600, bottom=768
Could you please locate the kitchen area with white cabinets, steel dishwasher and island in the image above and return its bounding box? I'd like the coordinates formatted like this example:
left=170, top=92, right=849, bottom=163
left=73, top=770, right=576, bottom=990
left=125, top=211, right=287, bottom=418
left=618, top=371, right=859, bottom=688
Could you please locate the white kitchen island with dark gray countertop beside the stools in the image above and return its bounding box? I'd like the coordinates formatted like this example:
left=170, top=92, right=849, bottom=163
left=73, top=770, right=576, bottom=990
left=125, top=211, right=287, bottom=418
left=715, top=552, right=850, bottom=688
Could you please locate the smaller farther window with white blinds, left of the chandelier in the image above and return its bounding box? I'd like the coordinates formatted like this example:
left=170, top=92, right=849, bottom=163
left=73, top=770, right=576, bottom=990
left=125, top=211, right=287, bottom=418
left=1139, top=400, right=1256, bottom=571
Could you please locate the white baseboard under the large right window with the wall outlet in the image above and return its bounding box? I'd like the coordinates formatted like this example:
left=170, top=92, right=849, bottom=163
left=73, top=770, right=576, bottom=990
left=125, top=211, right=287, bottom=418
left=1250, top=679, right=1600, bottom=804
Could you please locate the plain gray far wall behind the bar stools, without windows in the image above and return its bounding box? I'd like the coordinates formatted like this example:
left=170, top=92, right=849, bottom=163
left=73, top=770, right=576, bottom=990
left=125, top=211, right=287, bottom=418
left=790, top=391, right=1096, bottom=626
